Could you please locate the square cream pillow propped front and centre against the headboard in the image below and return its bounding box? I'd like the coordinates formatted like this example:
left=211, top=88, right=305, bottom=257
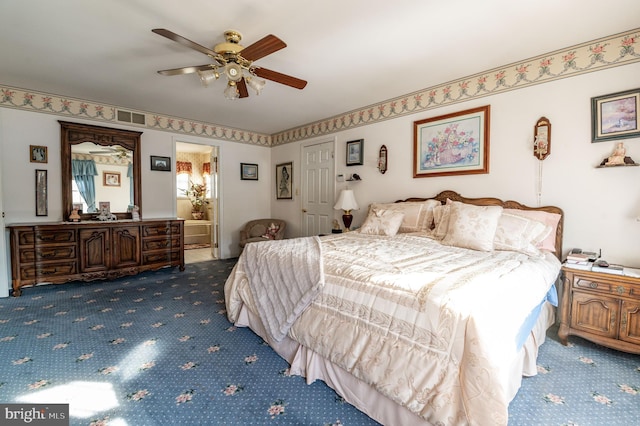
left=442, top=201, right=503, bottom=251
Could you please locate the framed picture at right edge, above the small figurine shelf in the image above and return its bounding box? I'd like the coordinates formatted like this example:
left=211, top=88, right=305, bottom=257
left=591, top=89, right=640, bottom=142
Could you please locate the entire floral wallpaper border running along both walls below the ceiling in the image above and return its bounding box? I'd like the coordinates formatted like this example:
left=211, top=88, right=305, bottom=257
left=0, top=28, right=640, bottom=146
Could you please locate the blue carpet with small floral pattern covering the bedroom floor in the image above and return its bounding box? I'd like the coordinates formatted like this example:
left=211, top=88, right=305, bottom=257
left=0, top=259, right=640, bottom=426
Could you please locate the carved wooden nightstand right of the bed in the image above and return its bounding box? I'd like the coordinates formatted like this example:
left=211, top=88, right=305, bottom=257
left=558, top=266, right=640, bottom=354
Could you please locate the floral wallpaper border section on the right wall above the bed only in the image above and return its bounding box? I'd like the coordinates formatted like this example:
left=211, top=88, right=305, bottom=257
left=271, top=28, right=640, bottom=146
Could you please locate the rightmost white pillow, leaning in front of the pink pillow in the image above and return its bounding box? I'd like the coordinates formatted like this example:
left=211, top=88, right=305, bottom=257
left=493, top=209, right=551, bottom=257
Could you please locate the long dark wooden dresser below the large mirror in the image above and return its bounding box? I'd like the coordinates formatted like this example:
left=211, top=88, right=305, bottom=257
left=7, top=219, right=184, bottom=296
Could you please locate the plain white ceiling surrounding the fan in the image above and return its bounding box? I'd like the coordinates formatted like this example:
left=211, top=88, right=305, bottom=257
left=0, top=0, right=640, bottom=134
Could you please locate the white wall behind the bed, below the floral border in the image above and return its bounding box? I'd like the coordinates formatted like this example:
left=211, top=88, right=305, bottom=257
left=271, top=63, right=640, bottom=267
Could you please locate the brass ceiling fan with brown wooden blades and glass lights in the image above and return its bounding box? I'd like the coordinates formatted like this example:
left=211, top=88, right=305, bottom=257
left=151, top=28, right=307, bottom=99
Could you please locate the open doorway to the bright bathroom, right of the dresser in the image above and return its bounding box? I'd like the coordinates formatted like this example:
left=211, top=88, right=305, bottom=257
left=176, top=142, right=220, bottom=263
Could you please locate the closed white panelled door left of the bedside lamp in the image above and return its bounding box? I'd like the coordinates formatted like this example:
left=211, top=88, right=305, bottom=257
left=301, top=140, right=335, bottom=237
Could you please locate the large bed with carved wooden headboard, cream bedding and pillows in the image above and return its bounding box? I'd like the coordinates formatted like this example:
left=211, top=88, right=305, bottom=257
left=225, top=191, right=563, bottom=425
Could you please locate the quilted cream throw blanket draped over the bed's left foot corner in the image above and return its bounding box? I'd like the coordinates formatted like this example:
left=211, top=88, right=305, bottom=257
left=239, top=237, right=324, bottom=342
